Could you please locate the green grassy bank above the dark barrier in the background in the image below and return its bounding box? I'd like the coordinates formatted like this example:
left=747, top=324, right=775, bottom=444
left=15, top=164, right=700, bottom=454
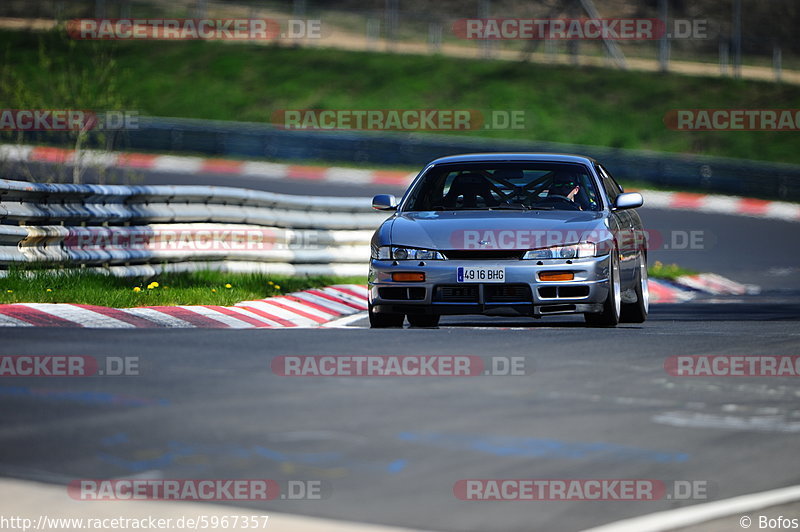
left=0, top=31, right=800, bottom=163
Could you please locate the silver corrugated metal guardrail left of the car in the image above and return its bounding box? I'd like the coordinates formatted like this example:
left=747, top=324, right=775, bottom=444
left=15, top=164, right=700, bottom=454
left=0, top=179, right=385, bottom=275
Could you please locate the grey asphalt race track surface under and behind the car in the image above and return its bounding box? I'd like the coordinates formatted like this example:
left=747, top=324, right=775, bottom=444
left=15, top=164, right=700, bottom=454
left=0, top=160, right=800, bottom=532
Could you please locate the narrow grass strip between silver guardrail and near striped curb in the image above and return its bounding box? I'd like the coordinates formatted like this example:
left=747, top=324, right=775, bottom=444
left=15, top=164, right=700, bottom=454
left=0, top=270, right=366, bottom=308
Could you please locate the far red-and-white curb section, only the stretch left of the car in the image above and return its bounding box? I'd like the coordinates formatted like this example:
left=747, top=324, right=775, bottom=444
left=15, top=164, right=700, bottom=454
left=0, top=144, right=416, bottom=187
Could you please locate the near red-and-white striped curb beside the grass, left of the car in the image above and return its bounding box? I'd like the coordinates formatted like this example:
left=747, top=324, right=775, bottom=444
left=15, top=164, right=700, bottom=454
left=0, top=284, right=367, bottom=329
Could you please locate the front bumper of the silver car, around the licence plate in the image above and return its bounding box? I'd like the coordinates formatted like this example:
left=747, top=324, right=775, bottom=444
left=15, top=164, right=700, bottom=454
left=369, top=255, right=610, bottom=317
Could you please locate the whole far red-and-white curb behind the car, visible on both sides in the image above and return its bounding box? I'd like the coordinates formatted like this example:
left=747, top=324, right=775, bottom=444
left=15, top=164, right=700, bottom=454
left=0, top=144, right=800, bottom=222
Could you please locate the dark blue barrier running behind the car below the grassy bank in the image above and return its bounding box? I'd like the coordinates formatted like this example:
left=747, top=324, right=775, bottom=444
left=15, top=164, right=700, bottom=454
left=21, top=117, right=800, bottom=201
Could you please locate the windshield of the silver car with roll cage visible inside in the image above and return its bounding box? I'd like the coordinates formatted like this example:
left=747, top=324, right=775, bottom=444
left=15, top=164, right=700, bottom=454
left=403, top=162, right=601, bottom=211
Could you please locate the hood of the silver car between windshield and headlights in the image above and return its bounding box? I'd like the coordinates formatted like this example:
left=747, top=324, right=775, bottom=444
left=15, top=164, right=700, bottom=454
left=391, top=210, right=608, bottom=250
